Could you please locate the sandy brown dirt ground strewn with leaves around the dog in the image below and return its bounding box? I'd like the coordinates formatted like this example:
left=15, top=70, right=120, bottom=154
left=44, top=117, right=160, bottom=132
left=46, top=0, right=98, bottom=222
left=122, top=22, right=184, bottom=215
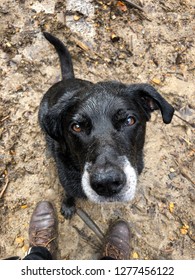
left=0, top=0, right=195, bottom=260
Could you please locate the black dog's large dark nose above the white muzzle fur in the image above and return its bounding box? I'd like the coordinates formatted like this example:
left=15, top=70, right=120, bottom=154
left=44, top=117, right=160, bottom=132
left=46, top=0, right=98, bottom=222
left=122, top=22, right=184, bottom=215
left=90, top=168, right=126, bottom=197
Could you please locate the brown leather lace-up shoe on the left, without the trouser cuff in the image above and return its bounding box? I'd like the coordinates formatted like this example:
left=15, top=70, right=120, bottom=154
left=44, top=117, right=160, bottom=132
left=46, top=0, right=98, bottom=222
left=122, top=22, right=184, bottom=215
left=29, top=201, right=58, bottom=259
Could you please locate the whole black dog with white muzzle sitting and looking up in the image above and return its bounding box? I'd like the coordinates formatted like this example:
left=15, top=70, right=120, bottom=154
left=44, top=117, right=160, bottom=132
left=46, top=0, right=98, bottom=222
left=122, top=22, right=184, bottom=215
left=39, top=32, right=174, bottom=218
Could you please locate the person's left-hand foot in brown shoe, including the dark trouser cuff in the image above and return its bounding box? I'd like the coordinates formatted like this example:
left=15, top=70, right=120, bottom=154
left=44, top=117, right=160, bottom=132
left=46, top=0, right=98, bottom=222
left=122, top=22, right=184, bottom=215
left=23, top=201, right=58, bottom=260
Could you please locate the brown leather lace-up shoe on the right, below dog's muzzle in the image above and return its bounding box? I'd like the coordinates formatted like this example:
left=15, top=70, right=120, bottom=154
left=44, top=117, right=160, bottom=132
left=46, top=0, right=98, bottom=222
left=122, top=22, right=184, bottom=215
left=103, top=220, right=131, bottom=260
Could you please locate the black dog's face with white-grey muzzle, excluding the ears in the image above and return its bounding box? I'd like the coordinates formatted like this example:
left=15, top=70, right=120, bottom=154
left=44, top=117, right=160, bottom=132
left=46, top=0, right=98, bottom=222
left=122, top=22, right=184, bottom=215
left=64, top=86, right=142, bottom=202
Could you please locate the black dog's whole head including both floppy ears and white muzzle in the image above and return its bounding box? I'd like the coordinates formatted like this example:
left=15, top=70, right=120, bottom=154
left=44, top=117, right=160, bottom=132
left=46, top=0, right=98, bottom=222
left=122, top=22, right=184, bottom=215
left=44, top=79, right=173, bottom=202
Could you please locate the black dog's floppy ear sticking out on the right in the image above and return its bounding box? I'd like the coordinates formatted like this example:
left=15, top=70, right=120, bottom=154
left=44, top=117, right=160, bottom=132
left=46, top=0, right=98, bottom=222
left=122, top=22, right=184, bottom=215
left=128, top=84, right=174, bottom=124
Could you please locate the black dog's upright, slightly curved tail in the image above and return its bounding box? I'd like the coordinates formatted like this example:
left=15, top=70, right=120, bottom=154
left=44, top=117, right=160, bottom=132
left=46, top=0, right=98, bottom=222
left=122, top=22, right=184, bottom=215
left=43, top=32, right=74, bottom=80
